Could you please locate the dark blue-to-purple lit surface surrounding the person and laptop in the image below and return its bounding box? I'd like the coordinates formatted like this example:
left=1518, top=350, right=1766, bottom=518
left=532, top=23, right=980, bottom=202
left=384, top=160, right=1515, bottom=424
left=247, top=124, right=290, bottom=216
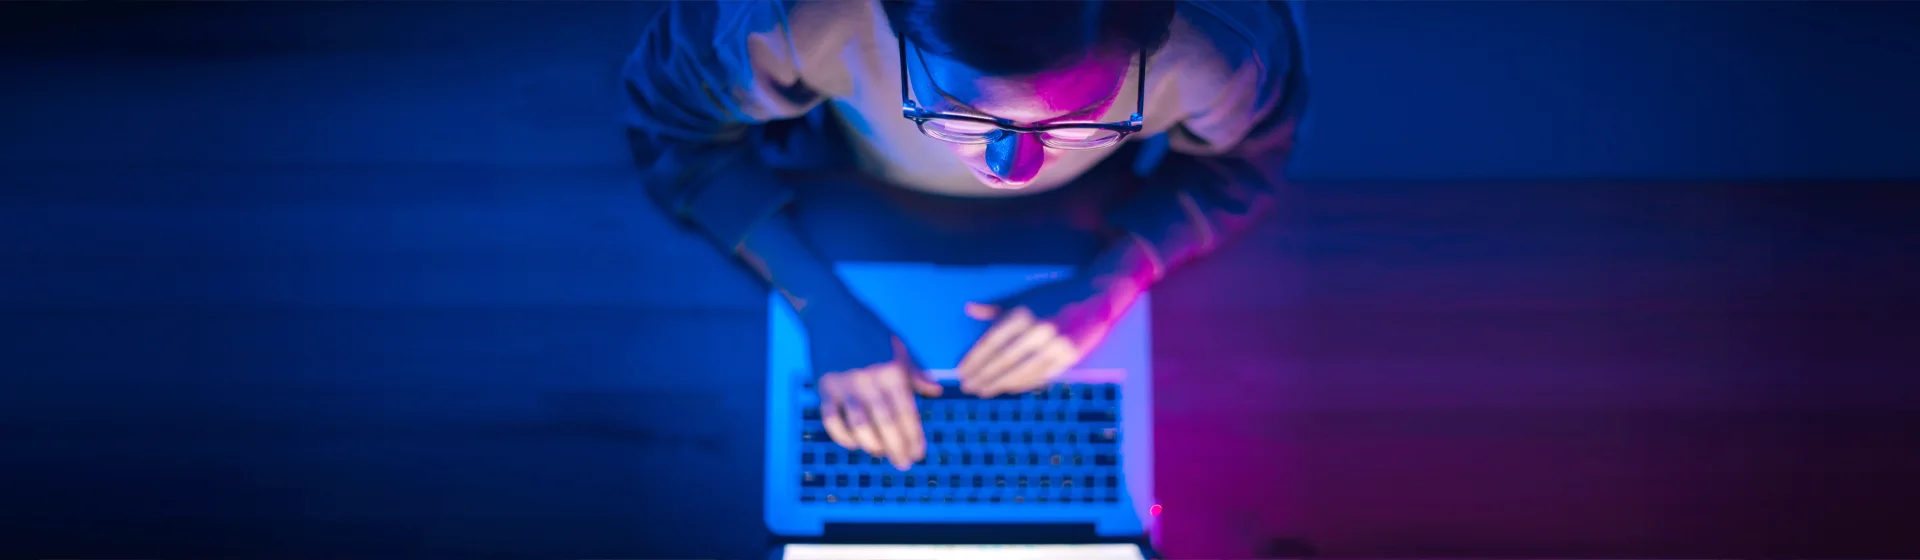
left=0, top=2, right=1920, bottom=558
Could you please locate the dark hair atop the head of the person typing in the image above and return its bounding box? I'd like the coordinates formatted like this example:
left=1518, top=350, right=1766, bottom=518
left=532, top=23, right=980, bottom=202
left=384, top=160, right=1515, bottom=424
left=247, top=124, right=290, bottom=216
left=881, top=0, right=1173, bottom=75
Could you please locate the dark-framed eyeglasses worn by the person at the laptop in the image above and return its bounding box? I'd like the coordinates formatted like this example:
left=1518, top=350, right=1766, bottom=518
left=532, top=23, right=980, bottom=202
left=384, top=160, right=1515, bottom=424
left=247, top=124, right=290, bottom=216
left=895, top=36, right=1146, bottom=150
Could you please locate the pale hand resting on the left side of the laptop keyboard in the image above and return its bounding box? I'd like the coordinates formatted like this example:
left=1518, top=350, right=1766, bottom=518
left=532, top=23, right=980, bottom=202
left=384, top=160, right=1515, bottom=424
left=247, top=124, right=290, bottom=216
left=816, top=338, right=941, bottom=470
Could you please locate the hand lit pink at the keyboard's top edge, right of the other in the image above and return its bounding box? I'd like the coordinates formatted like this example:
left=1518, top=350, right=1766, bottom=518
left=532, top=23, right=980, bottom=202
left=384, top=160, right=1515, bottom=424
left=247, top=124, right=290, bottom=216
left=960, top=272, right=1139, bottom=397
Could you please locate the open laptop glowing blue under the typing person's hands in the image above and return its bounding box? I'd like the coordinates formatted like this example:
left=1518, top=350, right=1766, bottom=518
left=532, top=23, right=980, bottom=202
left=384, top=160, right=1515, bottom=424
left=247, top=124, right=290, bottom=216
left=764, top=263, right=1160, bottom=560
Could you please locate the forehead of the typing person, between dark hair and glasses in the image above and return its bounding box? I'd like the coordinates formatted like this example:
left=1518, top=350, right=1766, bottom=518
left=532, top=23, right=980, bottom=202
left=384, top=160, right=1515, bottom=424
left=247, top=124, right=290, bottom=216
left=922, top=52, right=1133, bottom=123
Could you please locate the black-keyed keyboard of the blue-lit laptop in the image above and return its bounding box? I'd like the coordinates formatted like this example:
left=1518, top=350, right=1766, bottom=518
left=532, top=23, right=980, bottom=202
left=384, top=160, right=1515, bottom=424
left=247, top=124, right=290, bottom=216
left=795, top=382, right=1125, bottom=506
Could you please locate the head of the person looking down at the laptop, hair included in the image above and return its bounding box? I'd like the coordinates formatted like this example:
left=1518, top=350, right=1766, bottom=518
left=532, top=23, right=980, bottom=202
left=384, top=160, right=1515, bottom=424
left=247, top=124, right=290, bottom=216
left=881, top=0, right=1173, bottom=188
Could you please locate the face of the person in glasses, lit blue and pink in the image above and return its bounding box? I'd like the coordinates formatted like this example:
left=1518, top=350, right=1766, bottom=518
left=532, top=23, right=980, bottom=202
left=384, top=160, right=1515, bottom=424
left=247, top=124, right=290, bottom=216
left=908, top=50, right=1133, bottom=190
